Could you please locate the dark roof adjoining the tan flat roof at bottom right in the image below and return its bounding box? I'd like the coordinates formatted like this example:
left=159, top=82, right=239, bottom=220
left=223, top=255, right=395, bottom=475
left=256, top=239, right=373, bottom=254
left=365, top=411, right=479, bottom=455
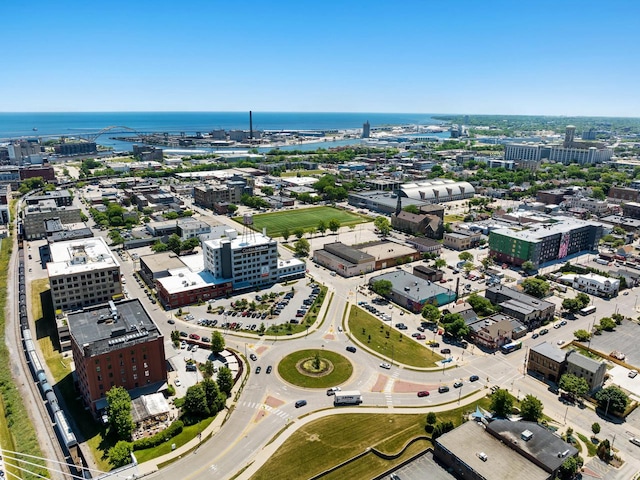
left=487, top=420, right=578, bottom=472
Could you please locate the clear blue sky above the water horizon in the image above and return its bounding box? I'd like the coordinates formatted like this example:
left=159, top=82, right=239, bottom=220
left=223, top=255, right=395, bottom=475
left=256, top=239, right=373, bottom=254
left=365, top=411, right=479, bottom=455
left=0, top=0, right=640, bottom=117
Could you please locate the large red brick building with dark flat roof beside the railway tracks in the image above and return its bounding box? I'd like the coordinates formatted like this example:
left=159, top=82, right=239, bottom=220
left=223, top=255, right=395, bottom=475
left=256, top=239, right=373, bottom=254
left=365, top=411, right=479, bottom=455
left=67, top=299, right=167, bottom=417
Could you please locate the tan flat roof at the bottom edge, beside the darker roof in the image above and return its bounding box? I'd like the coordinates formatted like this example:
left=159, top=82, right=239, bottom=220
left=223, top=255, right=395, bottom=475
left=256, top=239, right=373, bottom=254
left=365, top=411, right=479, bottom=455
left=436, top=421, right=549, bottom=480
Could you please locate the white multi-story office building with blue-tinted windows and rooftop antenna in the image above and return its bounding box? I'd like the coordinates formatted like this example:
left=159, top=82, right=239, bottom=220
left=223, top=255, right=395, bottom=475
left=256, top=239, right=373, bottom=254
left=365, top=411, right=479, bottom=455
left=202, top=232, right=292, bottom=290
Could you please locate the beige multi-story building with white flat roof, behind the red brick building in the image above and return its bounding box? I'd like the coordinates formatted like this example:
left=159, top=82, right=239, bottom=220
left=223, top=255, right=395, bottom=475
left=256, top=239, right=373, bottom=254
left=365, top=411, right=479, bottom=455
left=47, top=237, right=122, bottom=313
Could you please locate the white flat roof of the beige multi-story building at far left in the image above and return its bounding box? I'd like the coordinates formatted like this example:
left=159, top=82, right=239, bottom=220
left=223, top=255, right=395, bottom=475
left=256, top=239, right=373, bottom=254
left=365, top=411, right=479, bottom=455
left=47, top=237, right=120, bottom=277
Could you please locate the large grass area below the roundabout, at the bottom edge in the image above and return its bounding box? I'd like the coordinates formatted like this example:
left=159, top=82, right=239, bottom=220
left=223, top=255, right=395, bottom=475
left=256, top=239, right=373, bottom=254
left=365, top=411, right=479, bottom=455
left=251, top=398, right=490, bottom=480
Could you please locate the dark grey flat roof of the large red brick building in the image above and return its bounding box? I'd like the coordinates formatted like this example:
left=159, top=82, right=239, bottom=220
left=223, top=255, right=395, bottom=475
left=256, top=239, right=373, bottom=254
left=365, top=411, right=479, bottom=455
left=67, top=299, right=162, bottom=356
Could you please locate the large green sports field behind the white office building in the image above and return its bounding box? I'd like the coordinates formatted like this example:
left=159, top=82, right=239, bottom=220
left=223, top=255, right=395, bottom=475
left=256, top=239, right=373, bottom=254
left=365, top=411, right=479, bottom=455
left=234, top=207, right=371, bottom=237
